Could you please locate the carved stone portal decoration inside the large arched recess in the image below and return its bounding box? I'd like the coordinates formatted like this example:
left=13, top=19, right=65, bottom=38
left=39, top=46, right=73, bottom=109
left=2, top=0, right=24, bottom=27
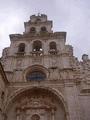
left=16, top=96, right=56, bottom=120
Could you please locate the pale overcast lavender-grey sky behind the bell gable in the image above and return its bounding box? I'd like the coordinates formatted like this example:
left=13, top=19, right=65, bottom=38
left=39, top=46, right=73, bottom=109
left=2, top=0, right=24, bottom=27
left=0, top=0, right=90, bottom=59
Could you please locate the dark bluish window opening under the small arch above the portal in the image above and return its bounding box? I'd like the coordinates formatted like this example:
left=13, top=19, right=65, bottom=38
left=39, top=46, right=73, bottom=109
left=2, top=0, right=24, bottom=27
left=26, top=71, right=46, bottom=81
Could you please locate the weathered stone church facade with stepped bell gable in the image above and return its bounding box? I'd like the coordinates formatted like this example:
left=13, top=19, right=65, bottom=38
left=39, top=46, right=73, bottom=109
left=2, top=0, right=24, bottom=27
left=0, top=14, right=90, bottom=120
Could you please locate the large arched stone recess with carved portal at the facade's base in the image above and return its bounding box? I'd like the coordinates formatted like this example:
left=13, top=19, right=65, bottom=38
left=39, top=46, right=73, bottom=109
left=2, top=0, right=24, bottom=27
left=4, top=87, right=68, bottom=120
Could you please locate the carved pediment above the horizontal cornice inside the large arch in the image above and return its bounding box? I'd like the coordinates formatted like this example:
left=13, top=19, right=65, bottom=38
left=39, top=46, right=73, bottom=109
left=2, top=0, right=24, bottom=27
left=17, top=98, right=55, bottom=109
